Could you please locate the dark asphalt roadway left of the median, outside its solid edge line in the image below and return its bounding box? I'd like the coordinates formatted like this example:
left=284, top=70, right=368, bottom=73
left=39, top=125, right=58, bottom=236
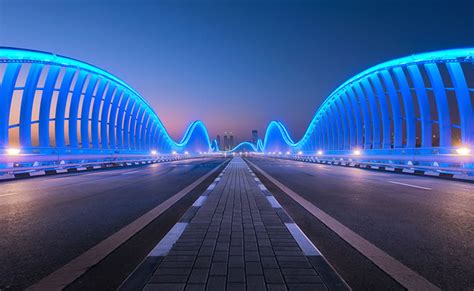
left=0, top=159, right=223, bottom=289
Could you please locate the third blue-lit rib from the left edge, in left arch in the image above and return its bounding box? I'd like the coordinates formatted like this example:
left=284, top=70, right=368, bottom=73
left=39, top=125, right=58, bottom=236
left=39, top=65, right=61, bottom=148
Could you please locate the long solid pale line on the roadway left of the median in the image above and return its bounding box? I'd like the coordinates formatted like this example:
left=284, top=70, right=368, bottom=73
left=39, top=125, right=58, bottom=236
left=28, top=161, right=225, bottom=290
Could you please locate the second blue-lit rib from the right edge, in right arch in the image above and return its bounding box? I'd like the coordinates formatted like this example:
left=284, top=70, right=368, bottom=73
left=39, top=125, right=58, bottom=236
left=425, top=63, right=451, bottom=147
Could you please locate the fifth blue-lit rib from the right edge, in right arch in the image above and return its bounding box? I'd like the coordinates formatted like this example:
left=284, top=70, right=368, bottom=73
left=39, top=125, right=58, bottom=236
left=380, top=70, right=403, bottom=148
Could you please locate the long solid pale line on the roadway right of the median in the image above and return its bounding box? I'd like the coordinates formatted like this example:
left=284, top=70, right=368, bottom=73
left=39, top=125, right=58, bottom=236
left=247, top=160, right=441, bottom=290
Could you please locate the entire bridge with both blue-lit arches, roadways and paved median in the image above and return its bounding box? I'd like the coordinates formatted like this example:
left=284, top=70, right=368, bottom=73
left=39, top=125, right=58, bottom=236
left=0, top=47, right=474, bottom=290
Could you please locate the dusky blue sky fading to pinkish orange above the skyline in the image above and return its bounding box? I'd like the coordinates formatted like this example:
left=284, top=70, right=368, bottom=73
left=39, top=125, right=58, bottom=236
left=0, top=0, right=474, bottom=145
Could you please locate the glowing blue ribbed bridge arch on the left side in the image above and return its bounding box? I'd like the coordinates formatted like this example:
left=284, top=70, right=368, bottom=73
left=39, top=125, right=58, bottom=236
left=0, top=48, right=210, bottom=160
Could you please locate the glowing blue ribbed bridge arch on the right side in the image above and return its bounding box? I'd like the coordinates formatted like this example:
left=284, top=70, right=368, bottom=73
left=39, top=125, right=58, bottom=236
left=264, top=48, right=474, bottom=154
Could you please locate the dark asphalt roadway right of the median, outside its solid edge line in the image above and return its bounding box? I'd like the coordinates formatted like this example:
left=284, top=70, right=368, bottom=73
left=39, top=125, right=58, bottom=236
left=249, top=158, right=474, bottom=290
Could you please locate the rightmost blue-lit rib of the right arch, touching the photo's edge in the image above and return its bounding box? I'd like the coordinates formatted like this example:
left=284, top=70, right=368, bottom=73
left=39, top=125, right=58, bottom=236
left=446, top=62, right=474, bottom=145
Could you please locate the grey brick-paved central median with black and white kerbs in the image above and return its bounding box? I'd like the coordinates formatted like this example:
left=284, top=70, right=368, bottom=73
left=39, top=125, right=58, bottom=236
left=128, top=157, right=345, bottom=290
